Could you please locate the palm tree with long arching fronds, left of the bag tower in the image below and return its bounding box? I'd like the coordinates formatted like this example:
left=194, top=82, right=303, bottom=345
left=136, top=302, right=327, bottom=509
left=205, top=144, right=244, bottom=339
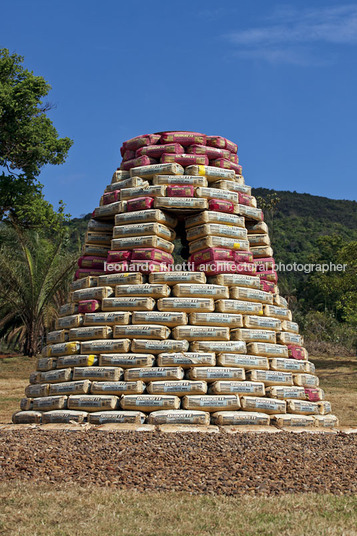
left=0, top=223, right=76, bottom=356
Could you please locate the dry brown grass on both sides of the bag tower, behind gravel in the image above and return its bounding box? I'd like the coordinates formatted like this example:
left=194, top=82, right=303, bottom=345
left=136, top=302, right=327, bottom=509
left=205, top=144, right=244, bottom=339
left=0, top=356, right=357, bottom=426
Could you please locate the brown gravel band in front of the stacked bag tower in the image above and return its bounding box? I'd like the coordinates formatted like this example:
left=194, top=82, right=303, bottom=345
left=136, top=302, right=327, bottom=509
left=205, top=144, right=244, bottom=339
left=0, top=430, right=357, bottom=495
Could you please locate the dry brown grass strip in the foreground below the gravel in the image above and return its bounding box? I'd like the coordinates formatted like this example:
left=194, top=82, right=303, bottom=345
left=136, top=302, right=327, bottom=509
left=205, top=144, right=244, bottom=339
left=0, top=483, right=357, bottom=536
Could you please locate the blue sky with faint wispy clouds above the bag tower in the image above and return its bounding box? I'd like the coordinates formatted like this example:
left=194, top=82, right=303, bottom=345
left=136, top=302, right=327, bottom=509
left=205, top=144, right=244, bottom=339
left=0, top=0, right=357, bottom=216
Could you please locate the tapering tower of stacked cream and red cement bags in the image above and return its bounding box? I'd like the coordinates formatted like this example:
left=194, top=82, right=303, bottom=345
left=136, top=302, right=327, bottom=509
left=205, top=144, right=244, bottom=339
left=13, top=132, right=337, bottom=427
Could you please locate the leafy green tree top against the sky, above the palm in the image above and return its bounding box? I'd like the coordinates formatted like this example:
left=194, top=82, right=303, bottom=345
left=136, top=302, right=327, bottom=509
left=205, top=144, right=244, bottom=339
left=0, top=48, right=73, bottom=225
